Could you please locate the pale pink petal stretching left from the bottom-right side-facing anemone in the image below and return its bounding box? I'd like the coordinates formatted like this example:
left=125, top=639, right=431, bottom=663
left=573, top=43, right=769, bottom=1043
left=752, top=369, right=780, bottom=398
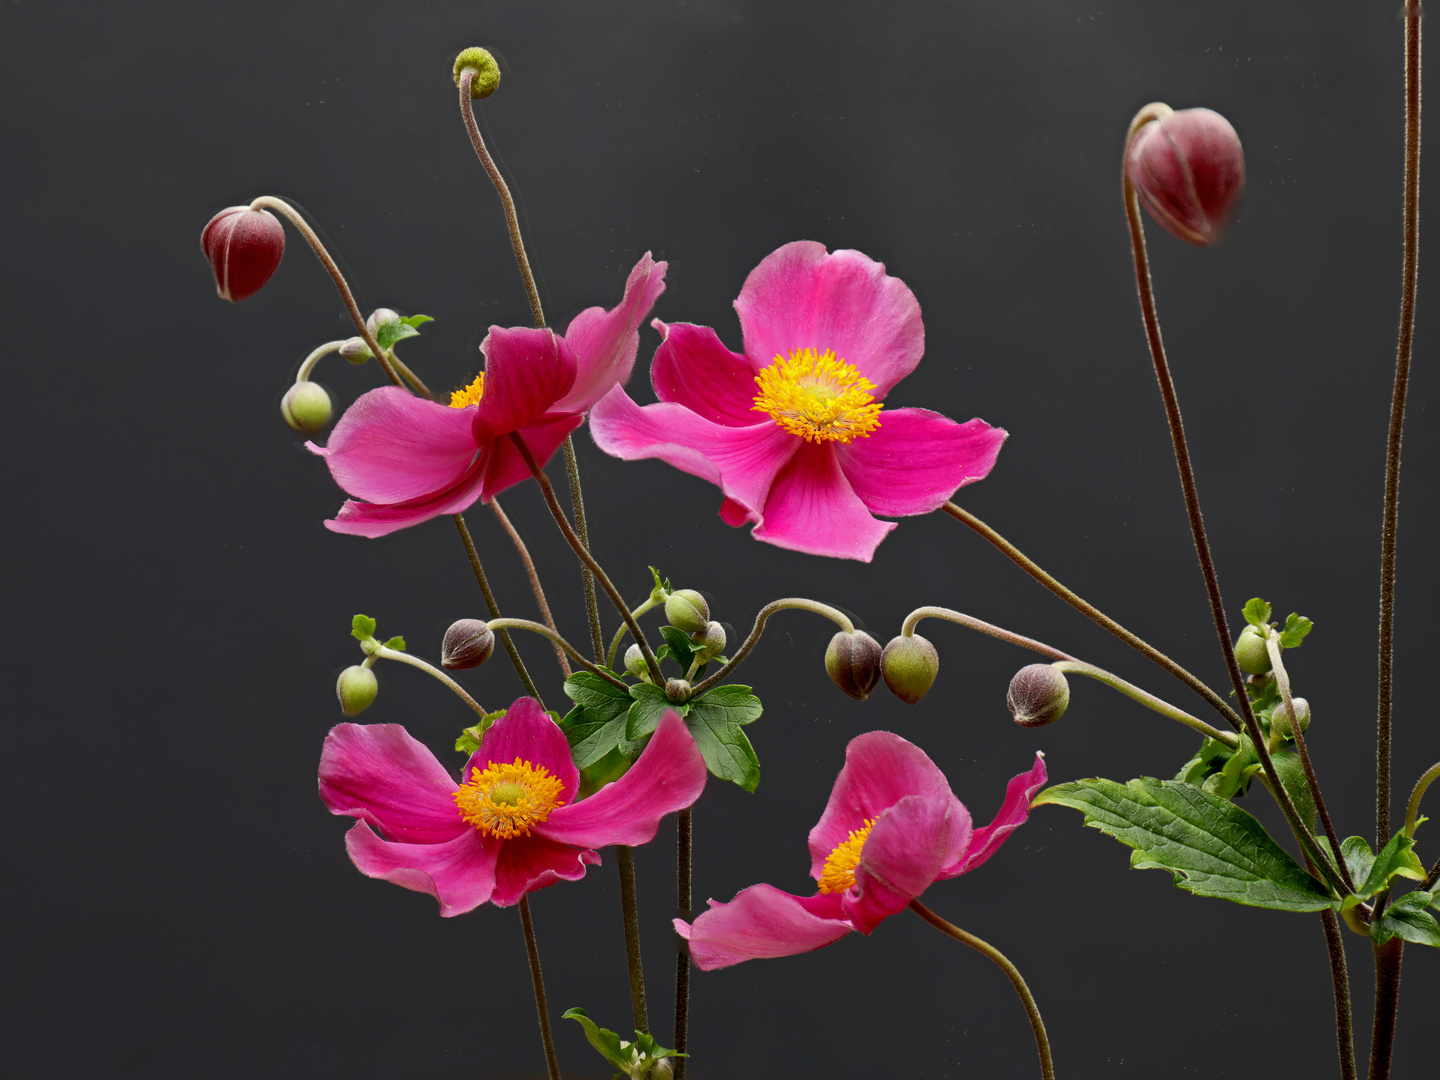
left=675, top=886, right=854, bottom=971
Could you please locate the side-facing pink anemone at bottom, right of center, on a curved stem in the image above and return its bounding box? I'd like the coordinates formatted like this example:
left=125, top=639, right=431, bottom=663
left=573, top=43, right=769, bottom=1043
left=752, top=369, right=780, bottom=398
left=675, top=732, right=1045, bottom=971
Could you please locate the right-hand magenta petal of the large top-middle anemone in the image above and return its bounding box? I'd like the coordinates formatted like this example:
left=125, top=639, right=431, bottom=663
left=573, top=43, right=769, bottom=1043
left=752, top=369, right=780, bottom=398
left=835, top=409, right=1005, bottom=517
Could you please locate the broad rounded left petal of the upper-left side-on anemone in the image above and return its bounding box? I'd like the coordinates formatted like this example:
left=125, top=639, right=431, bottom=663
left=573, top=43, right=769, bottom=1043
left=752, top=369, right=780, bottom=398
left=305, top=386, right=475, bottom=503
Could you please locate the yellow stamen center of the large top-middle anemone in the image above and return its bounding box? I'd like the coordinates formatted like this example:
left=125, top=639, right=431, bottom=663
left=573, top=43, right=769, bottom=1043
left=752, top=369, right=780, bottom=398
left=755, top=348, right=884, bottom=442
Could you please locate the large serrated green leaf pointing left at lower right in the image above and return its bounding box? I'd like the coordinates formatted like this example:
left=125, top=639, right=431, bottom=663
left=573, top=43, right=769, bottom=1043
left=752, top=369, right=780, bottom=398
left=1031, top=776, right=1333, bottom=912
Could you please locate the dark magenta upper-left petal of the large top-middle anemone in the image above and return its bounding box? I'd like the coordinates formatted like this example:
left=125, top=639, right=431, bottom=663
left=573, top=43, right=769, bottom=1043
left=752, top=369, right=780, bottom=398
left=649, top=318, right=765, bottom=428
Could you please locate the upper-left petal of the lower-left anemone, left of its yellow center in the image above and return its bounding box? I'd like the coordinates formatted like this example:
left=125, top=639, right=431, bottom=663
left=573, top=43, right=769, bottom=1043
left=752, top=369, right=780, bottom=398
left=320, top=724, right=469, bottom=844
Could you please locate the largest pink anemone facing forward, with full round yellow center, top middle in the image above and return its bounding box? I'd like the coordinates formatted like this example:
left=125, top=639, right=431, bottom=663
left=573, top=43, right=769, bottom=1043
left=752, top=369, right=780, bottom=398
left=590, top=240, right=1005, bottom=562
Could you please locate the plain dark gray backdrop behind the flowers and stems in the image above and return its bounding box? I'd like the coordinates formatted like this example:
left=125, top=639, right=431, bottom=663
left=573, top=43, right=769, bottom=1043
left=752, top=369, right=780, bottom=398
left=0, top=0, right=1440, bottom=1080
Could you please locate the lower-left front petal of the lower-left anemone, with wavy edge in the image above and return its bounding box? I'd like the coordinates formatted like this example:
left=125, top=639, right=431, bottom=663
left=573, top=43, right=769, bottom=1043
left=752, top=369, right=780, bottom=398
left=346, top=821, right=503, bottom=917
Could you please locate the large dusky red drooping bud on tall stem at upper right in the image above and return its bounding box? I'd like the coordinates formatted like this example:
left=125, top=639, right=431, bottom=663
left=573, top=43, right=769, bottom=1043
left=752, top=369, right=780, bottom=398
left=1125, top=109, right=1246, bottom=246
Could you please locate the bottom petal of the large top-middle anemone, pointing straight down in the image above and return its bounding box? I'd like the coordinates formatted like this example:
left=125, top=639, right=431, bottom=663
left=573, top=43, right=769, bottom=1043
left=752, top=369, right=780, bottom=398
left=748, top=440, right=896, bottom=563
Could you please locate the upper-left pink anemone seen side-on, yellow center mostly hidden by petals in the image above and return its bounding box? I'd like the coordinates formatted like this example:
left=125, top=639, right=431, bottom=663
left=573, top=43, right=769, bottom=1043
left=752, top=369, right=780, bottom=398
left=307, top=252, right=665, bottom=537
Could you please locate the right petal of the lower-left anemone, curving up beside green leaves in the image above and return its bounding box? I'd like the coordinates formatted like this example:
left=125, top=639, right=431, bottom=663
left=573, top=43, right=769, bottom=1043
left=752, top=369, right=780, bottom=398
left=534, top=710, right=706, bottom=848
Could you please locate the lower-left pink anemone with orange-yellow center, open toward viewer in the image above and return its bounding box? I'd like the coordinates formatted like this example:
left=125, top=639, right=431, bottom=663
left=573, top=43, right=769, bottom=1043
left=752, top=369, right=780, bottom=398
left=320, top=697, right=706, bottom=916
